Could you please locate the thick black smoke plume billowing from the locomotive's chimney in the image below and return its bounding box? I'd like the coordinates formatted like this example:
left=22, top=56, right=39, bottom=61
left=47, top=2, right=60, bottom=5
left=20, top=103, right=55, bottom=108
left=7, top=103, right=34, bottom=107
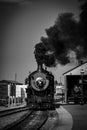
left=34, top=2, right=87, bottom=67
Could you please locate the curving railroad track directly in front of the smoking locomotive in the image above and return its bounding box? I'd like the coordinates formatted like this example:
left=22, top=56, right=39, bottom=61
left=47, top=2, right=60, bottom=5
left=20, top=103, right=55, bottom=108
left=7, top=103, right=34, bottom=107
left=2, top=111, right=48, bottom=130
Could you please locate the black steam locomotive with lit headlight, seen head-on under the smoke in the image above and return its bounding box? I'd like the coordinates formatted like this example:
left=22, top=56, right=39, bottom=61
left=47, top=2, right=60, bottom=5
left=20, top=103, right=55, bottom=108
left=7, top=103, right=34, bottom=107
left=26, top=64, right=55, bottom=110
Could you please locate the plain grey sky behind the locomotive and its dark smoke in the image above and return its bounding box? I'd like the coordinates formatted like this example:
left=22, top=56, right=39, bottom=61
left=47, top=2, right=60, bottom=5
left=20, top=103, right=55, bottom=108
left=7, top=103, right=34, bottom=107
left=0, top=0, right=79, bottom=83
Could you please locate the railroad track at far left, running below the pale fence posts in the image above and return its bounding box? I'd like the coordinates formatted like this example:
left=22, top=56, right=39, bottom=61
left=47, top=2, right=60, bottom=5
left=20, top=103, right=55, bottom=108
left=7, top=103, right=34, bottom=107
left=0, top=107, right=29, bottom=117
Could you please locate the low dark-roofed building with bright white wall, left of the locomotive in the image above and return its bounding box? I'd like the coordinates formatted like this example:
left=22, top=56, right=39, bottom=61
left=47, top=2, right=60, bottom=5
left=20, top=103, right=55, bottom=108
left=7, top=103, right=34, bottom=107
left=0, top=80, right=26, bottom=106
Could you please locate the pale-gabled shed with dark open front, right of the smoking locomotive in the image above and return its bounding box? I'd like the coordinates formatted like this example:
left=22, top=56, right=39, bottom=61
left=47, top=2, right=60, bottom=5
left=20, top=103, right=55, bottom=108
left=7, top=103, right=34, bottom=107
left=63, top=61, right=87, bottom=102
